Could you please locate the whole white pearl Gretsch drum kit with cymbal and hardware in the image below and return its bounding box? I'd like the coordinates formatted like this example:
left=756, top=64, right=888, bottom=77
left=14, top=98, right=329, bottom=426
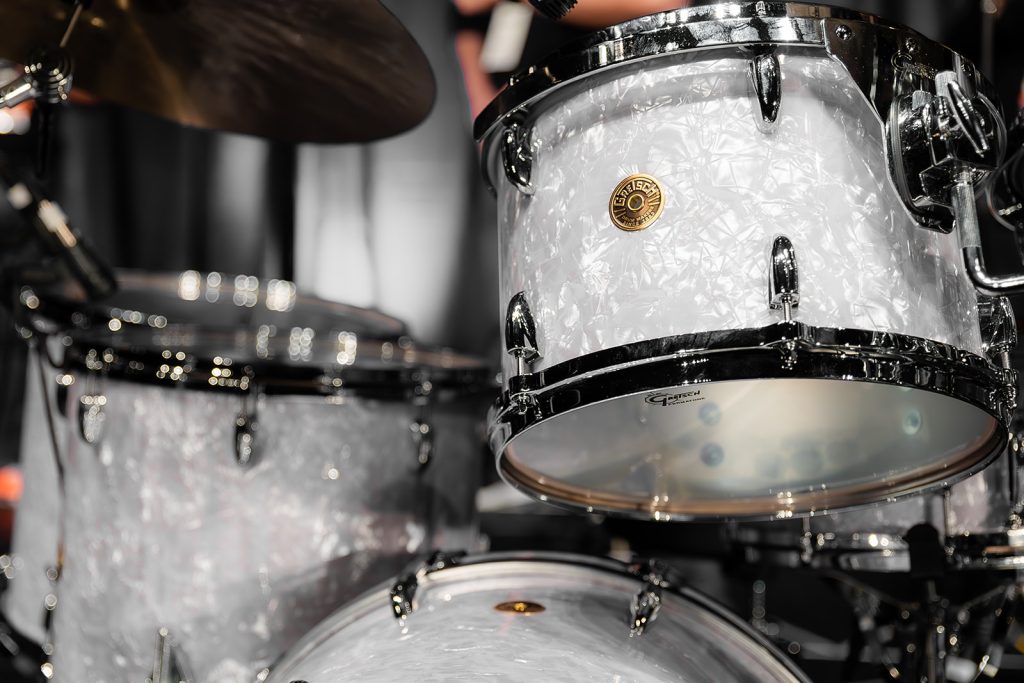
left=0, top=0, right=1024, bottom=683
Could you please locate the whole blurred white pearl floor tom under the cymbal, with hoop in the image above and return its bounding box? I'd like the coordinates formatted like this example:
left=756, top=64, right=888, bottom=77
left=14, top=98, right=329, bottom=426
left=11, top=272, right=489, bottom=683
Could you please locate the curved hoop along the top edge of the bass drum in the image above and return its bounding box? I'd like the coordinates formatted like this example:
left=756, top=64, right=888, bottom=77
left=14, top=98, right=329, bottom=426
left=268, top=551, right=809, bottom=683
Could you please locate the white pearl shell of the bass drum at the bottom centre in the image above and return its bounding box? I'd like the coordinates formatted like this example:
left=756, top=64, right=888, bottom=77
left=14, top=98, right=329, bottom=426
left=268, top=556, right=804, bottom=683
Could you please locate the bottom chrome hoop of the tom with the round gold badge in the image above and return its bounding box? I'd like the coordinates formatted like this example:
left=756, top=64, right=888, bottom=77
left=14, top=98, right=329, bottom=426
left=489, top=322, right=1017, bottom=520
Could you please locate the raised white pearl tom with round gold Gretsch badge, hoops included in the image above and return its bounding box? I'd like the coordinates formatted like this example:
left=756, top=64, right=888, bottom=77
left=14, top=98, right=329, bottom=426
left=477, top=2, right=1014, bottom=519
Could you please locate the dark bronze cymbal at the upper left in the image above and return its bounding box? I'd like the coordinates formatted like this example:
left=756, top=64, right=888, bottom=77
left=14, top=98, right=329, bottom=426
left=0, top=0, right=434, bottom=142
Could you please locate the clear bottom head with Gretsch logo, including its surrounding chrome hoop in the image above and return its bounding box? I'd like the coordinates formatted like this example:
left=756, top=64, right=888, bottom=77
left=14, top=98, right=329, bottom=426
left=492, top=326, right=1009, bottom=519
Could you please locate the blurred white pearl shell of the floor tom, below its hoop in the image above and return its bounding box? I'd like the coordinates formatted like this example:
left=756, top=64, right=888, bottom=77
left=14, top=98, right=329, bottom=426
left=48, top=378, right=480, bottom=683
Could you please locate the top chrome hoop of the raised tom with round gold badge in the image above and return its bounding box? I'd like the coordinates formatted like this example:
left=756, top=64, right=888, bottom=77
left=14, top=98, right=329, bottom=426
left=473, top=1, right=998, bottom=144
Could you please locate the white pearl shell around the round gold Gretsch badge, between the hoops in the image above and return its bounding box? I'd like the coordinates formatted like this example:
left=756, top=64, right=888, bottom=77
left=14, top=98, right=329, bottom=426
left=489, top=47, right=981, bottom=373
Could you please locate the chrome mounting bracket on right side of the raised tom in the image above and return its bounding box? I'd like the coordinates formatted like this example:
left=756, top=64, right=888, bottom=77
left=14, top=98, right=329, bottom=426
left=889, top=71, right=1006, bottom=232
